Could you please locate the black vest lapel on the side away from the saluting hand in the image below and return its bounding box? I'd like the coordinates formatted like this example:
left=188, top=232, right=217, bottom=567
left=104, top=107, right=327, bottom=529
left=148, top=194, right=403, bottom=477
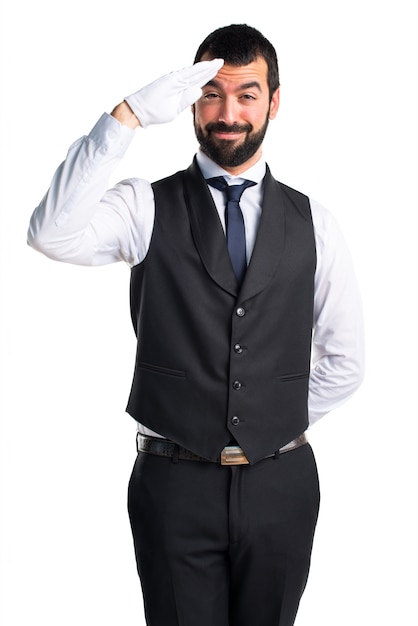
left=240, top=167, right=285, bottom=301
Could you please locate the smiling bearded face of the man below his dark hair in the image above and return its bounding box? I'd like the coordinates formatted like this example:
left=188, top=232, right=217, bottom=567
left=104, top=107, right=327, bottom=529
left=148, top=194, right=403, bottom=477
left=193, top=56, right=279, bottom=174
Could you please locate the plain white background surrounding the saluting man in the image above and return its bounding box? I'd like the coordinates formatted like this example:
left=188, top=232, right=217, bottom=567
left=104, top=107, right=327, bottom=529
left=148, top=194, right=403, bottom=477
left=0, top=0, right=418, bottom=626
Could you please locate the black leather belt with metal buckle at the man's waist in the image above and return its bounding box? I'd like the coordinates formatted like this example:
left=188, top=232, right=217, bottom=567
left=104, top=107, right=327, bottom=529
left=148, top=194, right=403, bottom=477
left=136, top=433, right=308, bottom=465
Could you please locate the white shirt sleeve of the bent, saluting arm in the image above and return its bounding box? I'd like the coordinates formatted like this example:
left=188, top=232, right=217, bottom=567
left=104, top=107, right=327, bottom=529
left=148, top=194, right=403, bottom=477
left=28, top=113, right=154, bottom=266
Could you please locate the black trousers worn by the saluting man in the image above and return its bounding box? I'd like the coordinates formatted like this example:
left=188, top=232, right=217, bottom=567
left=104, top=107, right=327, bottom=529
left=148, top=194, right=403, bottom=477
left=128, top=444, right=319, bottom=626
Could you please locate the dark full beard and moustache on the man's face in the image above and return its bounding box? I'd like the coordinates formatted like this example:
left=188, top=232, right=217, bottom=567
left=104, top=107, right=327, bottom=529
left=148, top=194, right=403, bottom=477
left=194, top=115, right=269, bottom=167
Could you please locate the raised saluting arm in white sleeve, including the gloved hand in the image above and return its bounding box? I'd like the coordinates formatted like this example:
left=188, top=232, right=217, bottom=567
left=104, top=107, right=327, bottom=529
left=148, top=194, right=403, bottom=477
left=28, top=59, right=223, bottom=265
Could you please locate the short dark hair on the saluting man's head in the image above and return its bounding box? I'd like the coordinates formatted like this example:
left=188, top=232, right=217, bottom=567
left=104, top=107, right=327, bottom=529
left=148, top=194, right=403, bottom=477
left=194, top=24, right=280, bottom=98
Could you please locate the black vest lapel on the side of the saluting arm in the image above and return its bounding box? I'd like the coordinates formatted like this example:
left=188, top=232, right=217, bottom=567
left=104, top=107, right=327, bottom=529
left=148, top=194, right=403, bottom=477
left=183, top=160, right=238, bottom=296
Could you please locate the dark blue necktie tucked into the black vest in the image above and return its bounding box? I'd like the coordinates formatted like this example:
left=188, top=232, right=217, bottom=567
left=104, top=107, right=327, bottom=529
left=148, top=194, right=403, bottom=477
left=206, top=176, right=256, bottom=285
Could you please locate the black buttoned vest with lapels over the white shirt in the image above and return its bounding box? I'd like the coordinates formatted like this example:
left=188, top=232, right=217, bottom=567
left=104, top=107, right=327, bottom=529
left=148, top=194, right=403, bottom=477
left=127, top=162, right=316, bottom=463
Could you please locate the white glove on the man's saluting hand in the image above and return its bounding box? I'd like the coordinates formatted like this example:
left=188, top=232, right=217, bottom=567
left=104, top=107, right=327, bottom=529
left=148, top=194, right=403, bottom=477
left=125, top=59, right=224, bottom=128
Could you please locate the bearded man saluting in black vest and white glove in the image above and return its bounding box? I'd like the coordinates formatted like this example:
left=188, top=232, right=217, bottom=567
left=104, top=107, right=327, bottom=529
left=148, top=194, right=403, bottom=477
left=29, top=25, right=363, bottom=626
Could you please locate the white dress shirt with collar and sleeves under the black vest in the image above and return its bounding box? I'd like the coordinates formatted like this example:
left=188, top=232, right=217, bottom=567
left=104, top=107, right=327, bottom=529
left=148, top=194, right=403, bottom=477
left=28, top=113, right=364, bottom=436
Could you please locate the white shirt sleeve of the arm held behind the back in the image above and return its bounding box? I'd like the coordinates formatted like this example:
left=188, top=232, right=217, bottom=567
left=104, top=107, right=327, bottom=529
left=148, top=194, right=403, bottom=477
left=308, top=200, right=364, bottom=425
